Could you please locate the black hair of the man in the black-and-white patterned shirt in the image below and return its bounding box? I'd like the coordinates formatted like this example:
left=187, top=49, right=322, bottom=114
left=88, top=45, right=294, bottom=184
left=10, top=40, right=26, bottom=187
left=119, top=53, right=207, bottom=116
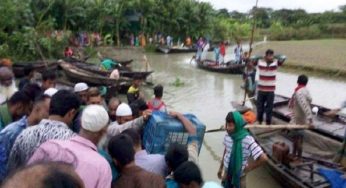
left=49, top=90, right=81, bottom=116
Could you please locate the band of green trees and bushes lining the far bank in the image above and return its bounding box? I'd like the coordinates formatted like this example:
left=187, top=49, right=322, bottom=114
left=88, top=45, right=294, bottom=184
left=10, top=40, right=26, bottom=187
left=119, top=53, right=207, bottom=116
left=0, top=0, right=346, bottom=60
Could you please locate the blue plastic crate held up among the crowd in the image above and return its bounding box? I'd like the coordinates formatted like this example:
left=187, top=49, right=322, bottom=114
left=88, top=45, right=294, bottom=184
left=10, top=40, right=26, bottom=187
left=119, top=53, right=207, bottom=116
left=143, top=111, right=206, bottom=154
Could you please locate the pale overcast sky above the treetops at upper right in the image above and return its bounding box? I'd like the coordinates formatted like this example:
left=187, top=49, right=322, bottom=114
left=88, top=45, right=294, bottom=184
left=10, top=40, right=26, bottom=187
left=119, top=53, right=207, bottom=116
left=199, top=0, right=346, bottom=13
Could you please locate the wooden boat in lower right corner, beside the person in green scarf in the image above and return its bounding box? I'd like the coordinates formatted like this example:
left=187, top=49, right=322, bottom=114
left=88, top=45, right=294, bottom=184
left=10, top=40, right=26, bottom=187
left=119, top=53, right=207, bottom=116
left=232, top=102, right=342, bottom=188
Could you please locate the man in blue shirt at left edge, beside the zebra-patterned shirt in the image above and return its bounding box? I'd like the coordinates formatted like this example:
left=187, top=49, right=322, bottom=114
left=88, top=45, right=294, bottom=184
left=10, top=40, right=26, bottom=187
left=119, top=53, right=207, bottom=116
left=0, top=96, right=50, bottom=182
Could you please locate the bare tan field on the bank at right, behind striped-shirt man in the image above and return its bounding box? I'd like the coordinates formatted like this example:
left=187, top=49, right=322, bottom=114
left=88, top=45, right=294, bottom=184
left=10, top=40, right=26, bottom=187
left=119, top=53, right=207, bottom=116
left=253, top=39, right=346, bottom=78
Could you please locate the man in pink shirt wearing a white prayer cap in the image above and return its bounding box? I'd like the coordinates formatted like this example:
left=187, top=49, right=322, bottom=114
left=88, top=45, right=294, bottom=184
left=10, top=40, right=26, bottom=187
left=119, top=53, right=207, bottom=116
left=29, top=105, right=112, bottom=188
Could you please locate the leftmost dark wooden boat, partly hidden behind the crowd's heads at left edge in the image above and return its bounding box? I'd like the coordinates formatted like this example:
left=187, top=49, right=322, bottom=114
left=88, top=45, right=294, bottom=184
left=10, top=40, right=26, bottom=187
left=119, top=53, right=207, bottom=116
left=12, top=61, right=58, bottom=78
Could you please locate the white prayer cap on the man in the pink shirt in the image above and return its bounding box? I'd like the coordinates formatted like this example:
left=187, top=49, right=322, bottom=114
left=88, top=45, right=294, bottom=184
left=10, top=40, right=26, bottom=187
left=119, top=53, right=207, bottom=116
left=81, top=105, right=109, bottom=132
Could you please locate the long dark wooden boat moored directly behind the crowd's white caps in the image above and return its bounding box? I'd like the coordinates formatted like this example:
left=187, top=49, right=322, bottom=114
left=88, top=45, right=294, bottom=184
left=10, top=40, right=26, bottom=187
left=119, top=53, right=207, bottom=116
left=60, top=63, right=130, bottom=87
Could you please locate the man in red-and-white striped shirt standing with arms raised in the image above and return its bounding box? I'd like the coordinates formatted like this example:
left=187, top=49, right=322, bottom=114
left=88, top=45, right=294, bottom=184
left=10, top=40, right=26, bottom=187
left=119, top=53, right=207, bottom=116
left=255, top=49, right=284, bottom=125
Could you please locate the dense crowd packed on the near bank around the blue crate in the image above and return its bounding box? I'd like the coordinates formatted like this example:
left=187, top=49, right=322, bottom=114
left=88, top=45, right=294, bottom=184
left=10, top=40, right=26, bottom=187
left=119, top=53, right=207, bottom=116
left=0, top=60, right=227, bottom=188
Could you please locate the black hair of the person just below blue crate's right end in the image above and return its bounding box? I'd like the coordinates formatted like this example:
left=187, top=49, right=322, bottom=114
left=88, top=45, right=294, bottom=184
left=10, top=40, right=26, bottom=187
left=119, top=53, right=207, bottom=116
left=165, top=143, right=189, bottom=171
